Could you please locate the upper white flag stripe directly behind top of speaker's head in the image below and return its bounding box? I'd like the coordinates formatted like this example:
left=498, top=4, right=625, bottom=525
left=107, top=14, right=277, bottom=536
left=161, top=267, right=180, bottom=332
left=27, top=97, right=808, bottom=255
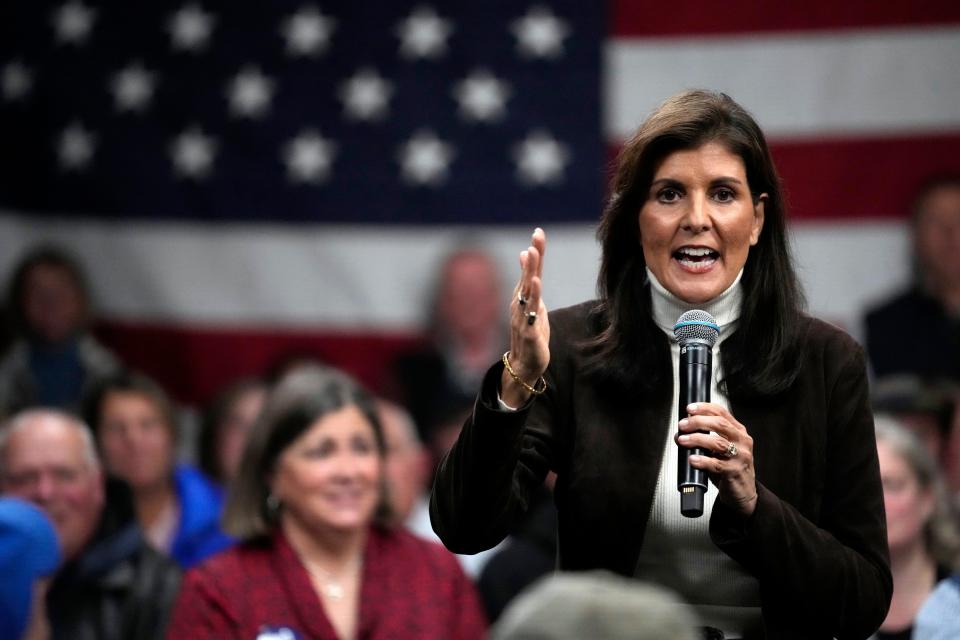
left=605, top=27, right=960, bottom=140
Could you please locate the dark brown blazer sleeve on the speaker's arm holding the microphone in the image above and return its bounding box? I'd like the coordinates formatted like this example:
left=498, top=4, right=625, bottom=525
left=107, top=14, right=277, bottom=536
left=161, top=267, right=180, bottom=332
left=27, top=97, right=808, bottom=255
left=710, top=336, right=893, bottom=640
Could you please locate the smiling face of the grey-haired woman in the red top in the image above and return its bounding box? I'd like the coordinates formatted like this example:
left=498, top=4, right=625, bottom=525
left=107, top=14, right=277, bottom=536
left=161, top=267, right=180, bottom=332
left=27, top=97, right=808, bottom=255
left=270, top=406, right=383, bottom=532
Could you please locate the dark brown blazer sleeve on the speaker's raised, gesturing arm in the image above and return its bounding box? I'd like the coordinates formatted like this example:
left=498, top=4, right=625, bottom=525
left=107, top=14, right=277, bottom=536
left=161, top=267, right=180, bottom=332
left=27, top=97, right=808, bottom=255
left=430, top=360, right=558, bottom=554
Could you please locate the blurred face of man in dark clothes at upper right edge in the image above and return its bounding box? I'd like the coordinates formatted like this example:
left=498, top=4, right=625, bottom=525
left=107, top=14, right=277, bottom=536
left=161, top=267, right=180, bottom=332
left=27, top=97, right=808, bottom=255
left=915, top=187, right=960, bottom=289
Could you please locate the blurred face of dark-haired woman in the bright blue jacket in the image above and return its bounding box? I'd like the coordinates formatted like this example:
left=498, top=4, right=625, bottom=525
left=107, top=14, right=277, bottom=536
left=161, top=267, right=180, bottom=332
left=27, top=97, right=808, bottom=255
left=97, top=391, right=174, bottom=491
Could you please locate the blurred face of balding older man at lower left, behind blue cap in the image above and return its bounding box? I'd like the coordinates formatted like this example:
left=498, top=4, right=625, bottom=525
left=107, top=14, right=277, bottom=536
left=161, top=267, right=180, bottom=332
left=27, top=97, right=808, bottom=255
left=0, top=417, right=104, bottom=560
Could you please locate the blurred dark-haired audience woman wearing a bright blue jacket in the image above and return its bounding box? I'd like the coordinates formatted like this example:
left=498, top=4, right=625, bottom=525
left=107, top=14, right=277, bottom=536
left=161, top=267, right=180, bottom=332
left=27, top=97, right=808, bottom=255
left=86, top=372, right=232, bottom=568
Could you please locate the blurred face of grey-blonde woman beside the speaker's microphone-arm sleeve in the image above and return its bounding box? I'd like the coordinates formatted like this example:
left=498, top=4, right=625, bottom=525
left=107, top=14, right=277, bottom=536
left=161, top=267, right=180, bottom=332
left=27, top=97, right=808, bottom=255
left=877, top=440, right=933, bottom=553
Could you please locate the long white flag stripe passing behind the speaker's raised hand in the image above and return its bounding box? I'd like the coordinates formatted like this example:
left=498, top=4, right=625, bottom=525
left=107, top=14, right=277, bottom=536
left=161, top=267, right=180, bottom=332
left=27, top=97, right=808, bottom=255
left=0, top=215, right=909, bottom=333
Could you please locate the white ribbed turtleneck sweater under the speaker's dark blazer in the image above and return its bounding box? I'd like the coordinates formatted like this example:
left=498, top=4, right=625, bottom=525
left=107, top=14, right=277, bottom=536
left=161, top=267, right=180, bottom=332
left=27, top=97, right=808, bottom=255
left=636, top=269, right=760, bottom=638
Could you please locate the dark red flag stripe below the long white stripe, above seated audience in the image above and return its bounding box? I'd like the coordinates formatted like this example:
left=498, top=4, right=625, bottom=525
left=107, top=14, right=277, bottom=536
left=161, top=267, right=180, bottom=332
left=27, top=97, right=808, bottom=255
left=96, top=321, right=418, bottom=406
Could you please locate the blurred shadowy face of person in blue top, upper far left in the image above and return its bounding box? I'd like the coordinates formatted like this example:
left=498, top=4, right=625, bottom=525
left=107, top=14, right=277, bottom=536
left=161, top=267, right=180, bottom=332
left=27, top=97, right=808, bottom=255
left=22, top=264, right=84, bottom=343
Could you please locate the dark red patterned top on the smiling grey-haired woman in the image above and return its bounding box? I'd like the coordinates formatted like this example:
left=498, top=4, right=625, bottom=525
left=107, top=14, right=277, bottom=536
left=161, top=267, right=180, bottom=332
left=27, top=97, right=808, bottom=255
left=167, top=527, right=486, bottom=640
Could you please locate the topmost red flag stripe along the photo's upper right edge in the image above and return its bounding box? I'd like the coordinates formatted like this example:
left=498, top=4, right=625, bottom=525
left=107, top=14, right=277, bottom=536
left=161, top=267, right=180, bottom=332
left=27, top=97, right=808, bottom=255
left=610, top=0, right=960, bottom=37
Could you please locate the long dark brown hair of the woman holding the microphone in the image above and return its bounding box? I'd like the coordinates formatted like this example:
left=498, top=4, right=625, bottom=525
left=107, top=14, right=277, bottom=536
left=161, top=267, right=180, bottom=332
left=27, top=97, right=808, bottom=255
left=587, top=90, right=804, bottom=396
